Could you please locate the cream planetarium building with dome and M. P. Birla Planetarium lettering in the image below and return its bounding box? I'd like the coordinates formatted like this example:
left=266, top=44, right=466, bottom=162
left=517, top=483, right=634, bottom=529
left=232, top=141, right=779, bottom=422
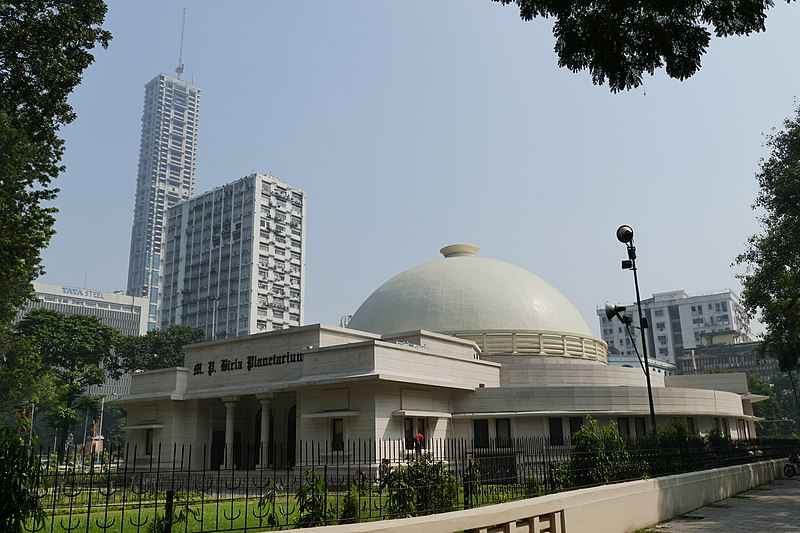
left=115, top=244, right=761, bottom=469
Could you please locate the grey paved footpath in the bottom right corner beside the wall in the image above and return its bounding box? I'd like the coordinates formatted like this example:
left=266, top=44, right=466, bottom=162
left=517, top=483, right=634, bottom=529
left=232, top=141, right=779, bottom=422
left=642, top=478, right=800, bottom=533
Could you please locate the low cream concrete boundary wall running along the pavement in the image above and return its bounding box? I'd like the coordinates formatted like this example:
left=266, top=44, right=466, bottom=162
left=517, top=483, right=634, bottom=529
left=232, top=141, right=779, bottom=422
left=303, top=460, right=785, bottom=533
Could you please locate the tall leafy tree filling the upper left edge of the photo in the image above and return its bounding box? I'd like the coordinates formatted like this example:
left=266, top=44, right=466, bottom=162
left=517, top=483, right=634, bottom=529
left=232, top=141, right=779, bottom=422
left=0, top=0, right=111, bottom=324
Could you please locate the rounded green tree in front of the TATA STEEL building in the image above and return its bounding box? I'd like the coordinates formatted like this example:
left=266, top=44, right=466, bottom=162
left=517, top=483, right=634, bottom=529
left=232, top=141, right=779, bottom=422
left=17, top=309, right=119, bottom=461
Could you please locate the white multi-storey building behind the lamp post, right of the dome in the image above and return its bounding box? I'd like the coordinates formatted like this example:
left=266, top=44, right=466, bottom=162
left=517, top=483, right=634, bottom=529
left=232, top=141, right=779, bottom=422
left=597, top=290, right=753, bottom=364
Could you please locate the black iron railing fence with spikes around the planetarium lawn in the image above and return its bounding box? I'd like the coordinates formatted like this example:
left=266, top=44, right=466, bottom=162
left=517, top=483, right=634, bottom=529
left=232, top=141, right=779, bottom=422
left=21, top=438, right=797, bottom=533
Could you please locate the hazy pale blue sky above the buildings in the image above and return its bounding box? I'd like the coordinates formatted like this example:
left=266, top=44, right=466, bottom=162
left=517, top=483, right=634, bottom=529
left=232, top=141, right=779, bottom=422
left=40, top=0, right=800, bottom=336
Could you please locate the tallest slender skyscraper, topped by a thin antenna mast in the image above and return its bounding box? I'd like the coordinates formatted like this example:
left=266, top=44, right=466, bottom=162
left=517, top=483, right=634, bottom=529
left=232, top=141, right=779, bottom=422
left=127, top=70, right=200, bottom=329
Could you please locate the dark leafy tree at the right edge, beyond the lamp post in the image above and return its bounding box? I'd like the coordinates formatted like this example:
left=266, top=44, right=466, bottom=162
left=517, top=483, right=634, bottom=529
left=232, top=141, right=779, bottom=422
left=736, top=103, right=800, bottom=372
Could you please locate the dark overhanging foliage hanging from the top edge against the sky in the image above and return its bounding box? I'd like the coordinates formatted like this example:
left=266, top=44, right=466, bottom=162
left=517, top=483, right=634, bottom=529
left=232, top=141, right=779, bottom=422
left=493, top=0, right=791, bottom=92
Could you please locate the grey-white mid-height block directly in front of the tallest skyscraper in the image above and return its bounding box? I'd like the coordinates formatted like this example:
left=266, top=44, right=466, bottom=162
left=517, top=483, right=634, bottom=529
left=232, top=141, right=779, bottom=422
left=161, top=174, right=306, bottom=339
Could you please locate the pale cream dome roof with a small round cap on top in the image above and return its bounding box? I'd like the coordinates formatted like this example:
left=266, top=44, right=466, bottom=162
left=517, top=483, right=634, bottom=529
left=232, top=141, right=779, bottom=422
left=348, top=244, right=592, bottom=337
